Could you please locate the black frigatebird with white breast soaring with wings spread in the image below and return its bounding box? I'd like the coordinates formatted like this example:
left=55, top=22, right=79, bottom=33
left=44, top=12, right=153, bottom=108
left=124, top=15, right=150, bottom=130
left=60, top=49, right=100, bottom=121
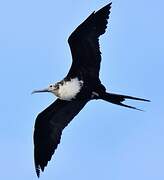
left=33, top=3, right=149, bottom=177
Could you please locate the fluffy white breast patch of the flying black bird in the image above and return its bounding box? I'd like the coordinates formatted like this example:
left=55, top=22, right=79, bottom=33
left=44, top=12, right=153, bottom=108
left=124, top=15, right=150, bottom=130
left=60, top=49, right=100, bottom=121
left=58, top=78, right=83, bottom=101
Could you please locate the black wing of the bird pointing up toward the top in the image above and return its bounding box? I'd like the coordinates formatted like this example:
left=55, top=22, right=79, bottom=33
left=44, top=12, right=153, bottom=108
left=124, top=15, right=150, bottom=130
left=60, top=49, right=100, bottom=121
left=67, top=3, right=112, bottom=78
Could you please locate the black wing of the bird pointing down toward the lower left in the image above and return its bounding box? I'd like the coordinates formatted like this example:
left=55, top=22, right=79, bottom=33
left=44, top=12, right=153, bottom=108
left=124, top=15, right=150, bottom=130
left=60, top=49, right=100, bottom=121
left=34, top=99, right=88, bottom=177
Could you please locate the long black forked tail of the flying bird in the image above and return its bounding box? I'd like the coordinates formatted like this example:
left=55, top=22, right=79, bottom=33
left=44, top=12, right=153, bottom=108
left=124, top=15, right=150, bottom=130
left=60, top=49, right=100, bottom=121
left=101, top=93, right=150, bottom=111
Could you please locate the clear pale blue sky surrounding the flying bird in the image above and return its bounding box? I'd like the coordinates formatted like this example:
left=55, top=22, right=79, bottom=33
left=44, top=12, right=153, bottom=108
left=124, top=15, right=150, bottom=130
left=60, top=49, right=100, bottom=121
left=0, top=0, right=164, bottom=180
